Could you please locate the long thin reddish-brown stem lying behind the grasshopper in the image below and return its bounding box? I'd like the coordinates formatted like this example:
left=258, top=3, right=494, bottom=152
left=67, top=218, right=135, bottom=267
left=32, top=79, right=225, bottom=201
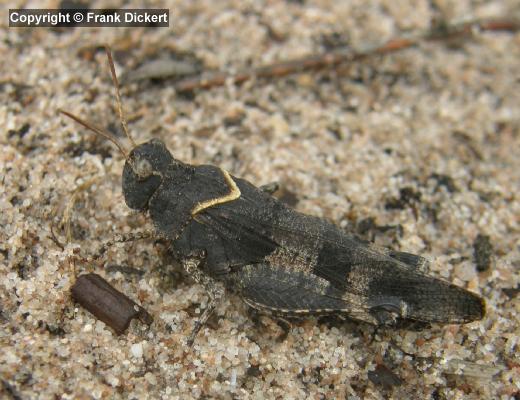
left=174, top=18, right=520, bottom=93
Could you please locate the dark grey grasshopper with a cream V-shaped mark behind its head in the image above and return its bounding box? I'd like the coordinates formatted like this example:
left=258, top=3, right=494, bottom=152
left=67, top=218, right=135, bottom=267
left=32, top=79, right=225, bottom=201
left=61, top=50, right=485, bottom=343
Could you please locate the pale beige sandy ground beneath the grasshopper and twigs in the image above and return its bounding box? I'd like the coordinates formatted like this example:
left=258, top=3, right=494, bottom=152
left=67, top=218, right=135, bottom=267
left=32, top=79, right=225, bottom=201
left=0, top=0, right=520, bottom=399
